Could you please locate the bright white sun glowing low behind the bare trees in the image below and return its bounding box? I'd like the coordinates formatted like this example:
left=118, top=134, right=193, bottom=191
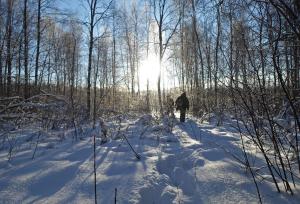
left=139, top=54, right=159, bottom=90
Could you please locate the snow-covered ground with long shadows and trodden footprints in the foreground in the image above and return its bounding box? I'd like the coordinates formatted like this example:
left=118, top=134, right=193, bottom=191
left=0, top=115, right=300, bottom=204
